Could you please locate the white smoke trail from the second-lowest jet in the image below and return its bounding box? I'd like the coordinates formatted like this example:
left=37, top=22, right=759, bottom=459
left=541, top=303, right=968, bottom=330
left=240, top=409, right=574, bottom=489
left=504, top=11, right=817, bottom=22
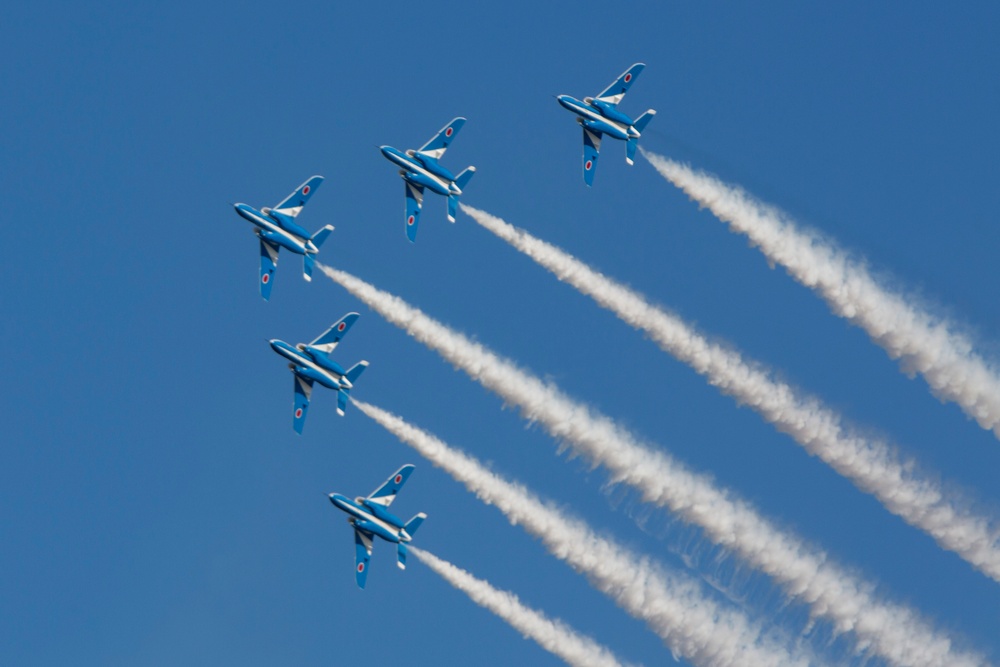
left=354, top=401, right=808, bottom=667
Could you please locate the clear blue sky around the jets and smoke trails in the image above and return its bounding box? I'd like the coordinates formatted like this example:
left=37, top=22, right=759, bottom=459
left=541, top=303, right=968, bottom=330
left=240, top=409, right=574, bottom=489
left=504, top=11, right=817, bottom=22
left=0, top=2, right=1000, bottom=665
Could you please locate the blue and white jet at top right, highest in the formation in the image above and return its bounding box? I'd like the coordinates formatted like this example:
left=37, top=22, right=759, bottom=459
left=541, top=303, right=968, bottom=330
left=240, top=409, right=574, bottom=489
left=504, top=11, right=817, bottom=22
left=556, top=63, right=656, bottom=186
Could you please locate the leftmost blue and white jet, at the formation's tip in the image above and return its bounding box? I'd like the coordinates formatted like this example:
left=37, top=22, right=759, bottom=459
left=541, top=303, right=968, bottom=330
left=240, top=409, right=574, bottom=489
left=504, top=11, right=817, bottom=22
left=233, top=176, right=333, bottom=301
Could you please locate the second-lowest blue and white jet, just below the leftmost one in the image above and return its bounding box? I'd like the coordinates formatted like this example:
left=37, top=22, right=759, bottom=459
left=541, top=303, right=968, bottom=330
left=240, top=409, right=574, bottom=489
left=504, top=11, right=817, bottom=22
left=268, top=313, right=368, bottom=435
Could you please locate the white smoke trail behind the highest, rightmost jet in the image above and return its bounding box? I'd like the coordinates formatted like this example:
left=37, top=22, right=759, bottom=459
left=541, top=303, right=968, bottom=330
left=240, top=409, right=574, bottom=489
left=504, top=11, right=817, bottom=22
left=642, top=151, right=1000, bottom=437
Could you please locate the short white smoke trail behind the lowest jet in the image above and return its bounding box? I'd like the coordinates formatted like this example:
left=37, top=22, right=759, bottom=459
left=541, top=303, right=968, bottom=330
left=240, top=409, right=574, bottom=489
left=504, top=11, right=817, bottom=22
left=410, top=547, right=626, bottom=667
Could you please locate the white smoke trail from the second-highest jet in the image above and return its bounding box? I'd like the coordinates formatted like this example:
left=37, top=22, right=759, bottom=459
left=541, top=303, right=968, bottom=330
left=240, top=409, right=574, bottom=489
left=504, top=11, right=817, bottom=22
left=462, top=204, right=1000, bottom=581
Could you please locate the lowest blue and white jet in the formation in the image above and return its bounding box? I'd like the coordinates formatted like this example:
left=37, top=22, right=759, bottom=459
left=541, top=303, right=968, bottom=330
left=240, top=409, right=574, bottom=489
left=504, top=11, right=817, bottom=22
left=330, top=464, right=427, bottom=588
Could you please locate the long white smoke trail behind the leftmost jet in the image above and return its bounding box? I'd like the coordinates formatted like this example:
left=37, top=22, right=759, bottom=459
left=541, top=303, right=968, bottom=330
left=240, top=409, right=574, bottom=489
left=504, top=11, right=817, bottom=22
left=318, top=264, right=985, bottom=667
